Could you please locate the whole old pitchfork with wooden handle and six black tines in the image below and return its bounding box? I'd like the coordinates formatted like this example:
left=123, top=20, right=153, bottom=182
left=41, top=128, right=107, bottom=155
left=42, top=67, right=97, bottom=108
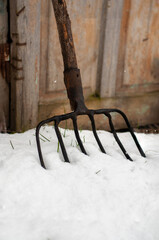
left=36, top=0, right=146, bottom=168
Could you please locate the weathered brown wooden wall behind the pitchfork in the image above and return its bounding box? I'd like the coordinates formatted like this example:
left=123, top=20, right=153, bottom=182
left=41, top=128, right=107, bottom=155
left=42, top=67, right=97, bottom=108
left=5, top=0, right=159, bottom=131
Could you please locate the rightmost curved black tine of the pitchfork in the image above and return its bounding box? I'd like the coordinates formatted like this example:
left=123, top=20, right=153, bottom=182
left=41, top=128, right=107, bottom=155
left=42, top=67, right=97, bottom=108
left=111, top=109, right=146, bottom=157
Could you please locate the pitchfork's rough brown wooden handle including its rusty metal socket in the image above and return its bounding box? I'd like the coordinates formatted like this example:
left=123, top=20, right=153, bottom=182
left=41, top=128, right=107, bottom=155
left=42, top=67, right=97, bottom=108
left=52, top=0, right=86, bottom=111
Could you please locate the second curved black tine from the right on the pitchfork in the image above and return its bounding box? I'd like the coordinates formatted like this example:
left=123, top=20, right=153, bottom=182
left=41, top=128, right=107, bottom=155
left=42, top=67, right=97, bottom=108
left=105, top=113, right=133, bottom=161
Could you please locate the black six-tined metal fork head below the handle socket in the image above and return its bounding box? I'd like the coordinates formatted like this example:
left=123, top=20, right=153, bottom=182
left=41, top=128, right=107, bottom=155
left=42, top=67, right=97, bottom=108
left=36, top=104, right=145, bottom=168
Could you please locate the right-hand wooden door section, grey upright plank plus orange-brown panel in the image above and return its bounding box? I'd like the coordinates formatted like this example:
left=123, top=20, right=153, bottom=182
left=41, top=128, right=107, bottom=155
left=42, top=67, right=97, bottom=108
left=100, top=0, right=159, bottom=126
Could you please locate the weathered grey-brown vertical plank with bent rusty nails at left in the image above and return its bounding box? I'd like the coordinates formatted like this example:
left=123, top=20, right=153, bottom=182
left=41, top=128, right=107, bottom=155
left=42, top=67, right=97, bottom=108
left=10, top=0, right=41, bottom=131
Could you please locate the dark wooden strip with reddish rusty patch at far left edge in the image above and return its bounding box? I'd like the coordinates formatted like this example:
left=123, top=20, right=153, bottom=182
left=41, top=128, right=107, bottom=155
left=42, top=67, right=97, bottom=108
left=0, top=0, right=9, bottom=132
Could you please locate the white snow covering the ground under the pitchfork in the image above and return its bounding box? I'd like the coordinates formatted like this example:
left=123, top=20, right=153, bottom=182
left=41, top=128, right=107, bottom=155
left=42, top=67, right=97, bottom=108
left=0, top=126, right=159, bottom=240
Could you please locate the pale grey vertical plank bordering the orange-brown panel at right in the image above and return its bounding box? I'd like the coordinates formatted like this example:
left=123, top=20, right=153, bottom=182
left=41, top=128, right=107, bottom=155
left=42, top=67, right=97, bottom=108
left=100, top=0, right=124, bottom=97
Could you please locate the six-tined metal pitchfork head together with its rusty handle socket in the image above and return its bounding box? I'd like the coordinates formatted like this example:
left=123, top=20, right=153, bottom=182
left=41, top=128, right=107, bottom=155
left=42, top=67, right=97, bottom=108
left=36, top=68, right=145, bottom=168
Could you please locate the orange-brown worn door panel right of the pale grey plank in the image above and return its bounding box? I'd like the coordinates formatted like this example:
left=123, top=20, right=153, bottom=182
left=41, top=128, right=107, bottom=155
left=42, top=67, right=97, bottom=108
left=116, top=0, right=159, bottom=96
